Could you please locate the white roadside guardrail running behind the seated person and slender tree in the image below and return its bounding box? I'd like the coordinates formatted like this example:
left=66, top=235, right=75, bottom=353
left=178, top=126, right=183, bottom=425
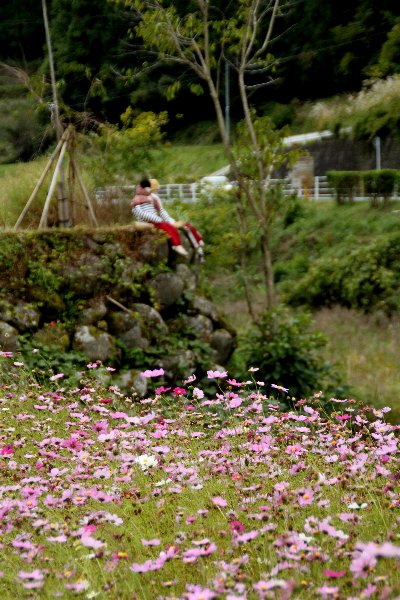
left=95, top=175, right=340, bottom=204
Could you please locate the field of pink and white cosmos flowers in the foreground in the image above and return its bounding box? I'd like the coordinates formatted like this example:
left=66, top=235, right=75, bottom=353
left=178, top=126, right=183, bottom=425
left=0, top=353, right=400, bottom=600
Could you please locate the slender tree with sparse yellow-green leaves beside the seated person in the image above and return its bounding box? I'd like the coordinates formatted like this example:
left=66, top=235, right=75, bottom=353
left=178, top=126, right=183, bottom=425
left=119, top=0, right=294, bottom=307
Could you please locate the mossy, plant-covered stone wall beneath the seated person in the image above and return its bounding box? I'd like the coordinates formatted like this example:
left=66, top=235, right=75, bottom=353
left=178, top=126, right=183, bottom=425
left=0, top=225, right=235, bottom=393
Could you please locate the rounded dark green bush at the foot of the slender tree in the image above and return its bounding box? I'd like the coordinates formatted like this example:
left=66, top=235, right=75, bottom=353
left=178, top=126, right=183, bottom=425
left=234, top=305, right=344, bottom=401
